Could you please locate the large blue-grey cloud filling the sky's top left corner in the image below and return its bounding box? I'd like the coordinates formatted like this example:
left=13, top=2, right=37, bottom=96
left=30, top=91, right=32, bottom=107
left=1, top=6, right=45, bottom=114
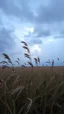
left=0, top=0, right=34, bottom=22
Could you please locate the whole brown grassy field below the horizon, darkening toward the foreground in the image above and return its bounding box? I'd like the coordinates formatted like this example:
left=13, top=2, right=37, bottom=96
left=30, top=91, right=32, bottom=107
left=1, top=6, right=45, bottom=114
left=0, top=66, right=64, bottom=114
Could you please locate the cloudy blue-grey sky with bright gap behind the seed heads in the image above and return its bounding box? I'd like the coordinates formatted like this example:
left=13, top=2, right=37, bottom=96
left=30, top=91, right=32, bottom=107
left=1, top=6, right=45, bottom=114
left=0, top=0, right=64, bottom=65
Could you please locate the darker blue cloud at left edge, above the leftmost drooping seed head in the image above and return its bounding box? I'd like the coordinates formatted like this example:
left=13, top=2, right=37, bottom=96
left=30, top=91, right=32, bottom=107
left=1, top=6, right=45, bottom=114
left=0, top=28, right=14, bottom=52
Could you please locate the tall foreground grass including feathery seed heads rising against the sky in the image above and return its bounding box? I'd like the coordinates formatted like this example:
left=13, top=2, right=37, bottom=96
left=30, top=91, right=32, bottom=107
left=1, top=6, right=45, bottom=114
left=0, top=41, right=64, bottom=114
